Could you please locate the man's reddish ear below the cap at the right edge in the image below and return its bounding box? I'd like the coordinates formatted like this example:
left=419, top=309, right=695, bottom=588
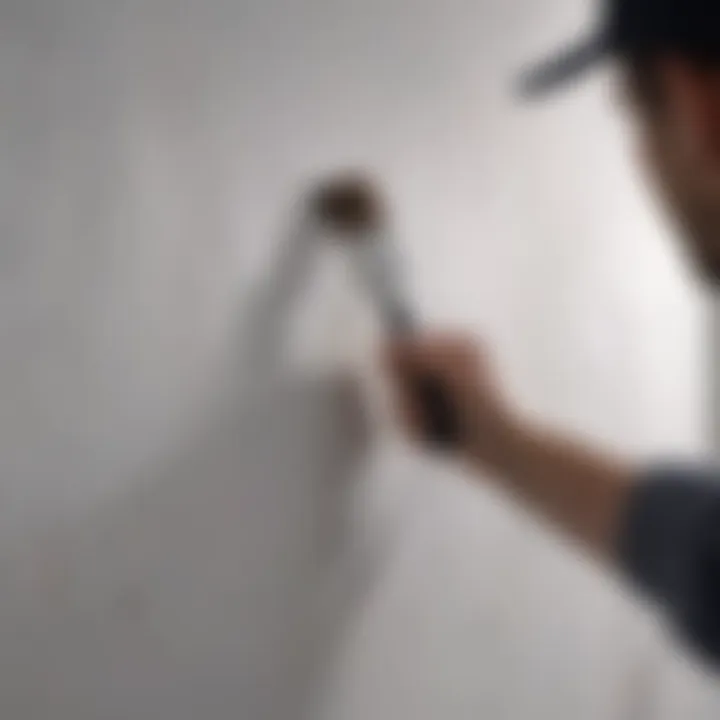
left=658, top=57, right=720, bottom=164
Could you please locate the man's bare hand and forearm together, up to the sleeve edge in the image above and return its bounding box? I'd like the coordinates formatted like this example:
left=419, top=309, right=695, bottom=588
left=387, top=335, right=638, bottom=559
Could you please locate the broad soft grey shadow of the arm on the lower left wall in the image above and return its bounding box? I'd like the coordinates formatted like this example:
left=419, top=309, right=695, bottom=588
left=0, top=372, right=380, bottom=720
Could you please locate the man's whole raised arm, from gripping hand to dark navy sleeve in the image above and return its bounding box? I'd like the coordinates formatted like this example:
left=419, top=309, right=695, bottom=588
left=389, top=326, right=720, bottom=662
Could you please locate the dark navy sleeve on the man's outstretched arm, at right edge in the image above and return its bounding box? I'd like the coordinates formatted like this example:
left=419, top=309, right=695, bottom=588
left=619, top=468, right=720, bottom=665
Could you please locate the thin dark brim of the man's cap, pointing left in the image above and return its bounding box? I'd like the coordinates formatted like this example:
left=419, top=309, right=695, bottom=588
left=520, top=36, right=612, bottom=98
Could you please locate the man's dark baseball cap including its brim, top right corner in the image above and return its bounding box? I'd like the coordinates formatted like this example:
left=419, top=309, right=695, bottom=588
left=521, top=0, right=720, bottom=97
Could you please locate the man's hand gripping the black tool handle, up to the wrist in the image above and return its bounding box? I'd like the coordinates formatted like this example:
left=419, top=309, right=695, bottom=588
left=385, top=334, right=515, bottom=464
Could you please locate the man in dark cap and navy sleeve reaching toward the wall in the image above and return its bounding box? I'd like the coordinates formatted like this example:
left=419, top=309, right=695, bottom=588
left=387, top=0, right=720, bottom=663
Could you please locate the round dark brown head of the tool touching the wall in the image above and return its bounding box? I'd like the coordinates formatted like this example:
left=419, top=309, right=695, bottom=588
left=310, top=174, right=388, bottom=239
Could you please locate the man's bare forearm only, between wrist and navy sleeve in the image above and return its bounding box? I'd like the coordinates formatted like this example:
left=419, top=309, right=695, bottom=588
left=471, top=420, right=634, bottom=557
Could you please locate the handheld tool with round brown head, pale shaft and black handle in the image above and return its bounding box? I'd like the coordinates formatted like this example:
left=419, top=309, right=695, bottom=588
left=311, top=176, right=461, bottom=451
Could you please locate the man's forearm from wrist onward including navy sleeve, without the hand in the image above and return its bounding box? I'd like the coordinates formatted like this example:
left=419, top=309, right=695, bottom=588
left=464, top=423, right=720, bottom=667
